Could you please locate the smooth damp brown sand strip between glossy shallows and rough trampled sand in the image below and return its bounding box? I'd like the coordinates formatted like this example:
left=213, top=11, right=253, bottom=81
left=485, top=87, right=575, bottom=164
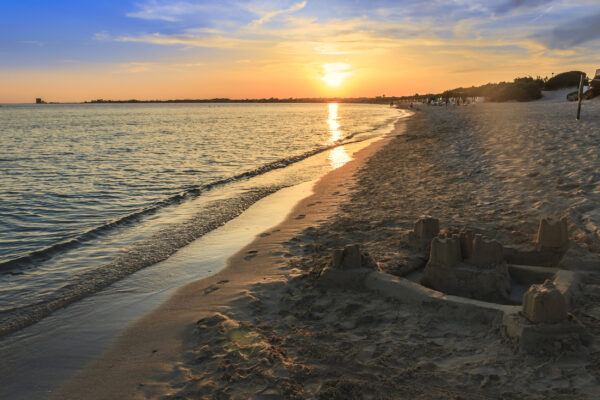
left=54, top=118, right=406, bottom=399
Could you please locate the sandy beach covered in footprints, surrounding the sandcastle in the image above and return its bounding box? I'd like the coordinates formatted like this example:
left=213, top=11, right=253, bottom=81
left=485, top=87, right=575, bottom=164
left=56, top=103, right=600, bottom=399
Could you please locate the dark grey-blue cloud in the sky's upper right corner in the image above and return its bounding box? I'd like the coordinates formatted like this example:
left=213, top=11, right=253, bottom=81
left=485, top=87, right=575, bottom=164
left=532, top=13, right=600, bottom=50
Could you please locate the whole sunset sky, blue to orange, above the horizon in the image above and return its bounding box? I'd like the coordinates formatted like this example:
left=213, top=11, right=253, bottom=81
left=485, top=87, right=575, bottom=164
left=0, top=0, right=600, bottom=103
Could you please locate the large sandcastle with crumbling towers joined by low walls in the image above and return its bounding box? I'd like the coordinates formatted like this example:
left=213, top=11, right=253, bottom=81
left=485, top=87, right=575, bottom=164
left=319, top=216, right=589, bottom=354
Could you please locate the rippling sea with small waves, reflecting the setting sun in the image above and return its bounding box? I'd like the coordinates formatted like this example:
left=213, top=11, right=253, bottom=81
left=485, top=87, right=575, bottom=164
left=0, top=104, right=403, bottom=330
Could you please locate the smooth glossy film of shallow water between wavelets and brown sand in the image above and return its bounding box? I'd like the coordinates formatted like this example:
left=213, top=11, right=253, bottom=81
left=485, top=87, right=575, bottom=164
left=0, top=182, right=313, bottom=400
